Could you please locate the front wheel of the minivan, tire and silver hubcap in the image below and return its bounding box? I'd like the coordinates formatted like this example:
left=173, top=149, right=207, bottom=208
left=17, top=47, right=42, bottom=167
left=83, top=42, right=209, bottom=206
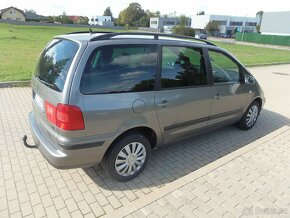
left=236, top=101, right=261, bottom=130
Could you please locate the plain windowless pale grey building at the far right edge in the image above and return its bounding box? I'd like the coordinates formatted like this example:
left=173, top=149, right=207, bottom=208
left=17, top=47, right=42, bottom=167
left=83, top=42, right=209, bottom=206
left=260, top=11, right=290, bottom=36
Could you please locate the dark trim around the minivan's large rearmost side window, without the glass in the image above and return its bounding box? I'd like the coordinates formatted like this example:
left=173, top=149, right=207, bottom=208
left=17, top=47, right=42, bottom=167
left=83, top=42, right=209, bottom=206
left=78, top=43, right=159, bottom=96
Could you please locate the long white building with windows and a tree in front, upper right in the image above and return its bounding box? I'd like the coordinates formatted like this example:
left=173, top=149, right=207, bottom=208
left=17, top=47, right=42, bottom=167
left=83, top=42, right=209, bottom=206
left=191, top=15, right=260, bottom=34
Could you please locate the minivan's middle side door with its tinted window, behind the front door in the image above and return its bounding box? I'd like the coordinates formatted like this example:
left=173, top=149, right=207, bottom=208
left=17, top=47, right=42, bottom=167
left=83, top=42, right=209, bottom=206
left=155, top=46, right=211, bottom=143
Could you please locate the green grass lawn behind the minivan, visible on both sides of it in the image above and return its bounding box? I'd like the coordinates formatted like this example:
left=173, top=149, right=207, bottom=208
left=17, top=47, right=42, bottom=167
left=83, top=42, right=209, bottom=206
left=0, top=24, right=290, bottom=82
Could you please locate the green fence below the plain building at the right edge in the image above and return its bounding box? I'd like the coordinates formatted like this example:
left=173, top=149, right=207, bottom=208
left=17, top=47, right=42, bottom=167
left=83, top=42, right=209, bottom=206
left=236, top=32, right=290, bottom=46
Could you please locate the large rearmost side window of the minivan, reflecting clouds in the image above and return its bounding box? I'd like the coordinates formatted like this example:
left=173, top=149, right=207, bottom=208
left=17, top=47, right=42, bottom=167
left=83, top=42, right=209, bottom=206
left=80, top=45, right=157, bottom=94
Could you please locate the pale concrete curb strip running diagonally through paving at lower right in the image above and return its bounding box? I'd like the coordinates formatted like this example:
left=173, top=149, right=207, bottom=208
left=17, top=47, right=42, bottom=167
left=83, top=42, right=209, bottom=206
left=103, top=126, right=290, bottom=217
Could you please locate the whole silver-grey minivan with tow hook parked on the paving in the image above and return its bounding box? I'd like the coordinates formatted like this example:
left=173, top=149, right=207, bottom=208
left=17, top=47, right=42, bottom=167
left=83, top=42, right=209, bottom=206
left=23, top=32, right=265, bottom=181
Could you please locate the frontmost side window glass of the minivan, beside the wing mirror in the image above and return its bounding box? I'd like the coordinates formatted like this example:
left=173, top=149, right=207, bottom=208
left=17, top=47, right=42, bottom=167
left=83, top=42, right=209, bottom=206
left=208, top=51, right=241, bottom=84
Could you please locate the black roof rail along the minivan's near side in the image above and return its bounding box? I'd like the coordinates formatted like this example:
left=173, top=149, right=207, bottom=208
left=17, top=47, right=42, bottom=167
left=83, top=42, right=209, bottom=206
left=90, top=32, right=216, bottom=46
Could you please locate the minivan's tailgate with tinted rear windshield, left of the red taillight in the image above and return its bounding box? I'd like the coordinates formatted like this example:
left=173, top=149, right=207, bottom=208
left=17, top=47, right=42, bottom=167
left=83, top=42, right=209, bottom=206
left=31, top=38, right=85, bottom=144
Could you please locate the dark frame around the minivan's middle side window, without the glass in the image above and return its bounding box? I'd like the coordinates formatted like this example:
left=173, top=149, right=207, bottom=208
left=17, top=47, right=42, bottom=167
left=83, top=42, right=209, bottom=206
left=155, top=44, right=211, bottom=91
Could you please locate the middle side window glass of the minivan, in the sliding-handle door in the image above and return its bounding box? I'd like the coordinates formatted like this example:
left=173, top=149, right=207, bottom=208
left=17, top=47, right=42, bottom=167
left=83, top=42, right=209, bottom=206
left=161, top=46, right=207, bottom=88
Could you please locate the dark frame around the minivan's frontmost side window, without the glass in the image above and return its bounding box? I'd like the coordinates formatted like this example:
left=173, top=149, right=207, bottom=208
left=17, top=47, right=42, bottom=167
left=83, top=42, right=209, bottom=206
left=206, top=48, right=245, bottom=86
